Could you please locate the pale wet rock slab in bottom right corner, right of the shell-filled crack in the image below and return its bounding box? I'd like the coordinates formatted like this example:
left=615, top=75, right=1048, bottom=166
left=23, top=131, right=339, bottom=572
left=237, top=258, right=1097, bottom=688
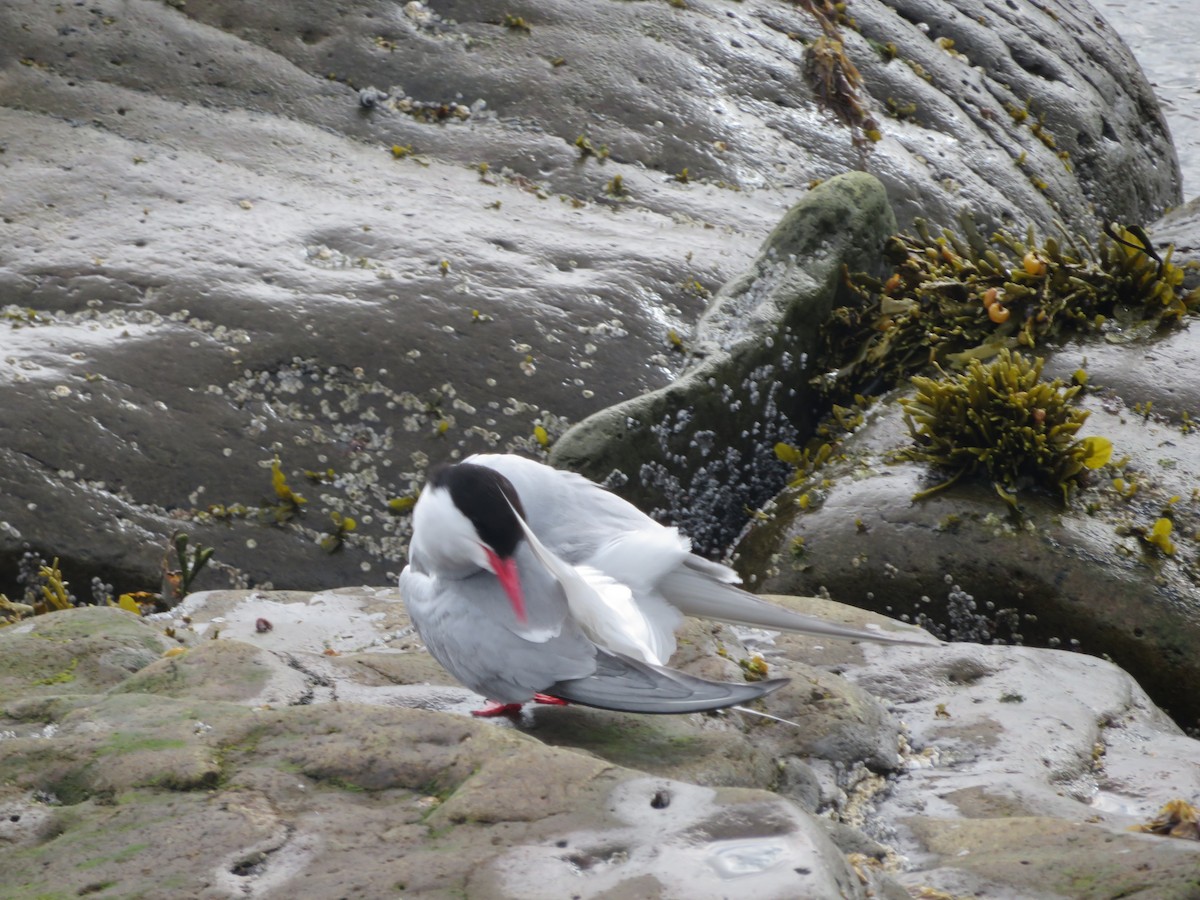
left=846, top=644, right=1200, bottom=898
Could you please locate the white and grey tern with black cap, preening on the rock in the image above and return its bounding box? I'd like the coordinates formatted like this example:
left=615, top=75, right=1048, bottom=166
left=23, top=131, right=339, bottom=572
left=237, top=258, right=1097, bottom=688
left=400, top=454, right=910, bottom=715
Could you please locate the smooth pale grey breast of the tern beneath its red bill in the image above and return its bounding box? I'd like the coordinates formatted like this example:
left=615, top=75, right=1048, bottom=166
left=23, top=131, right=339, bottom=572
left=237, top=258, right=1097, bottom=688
left=400, top=549, right=596, bottom=703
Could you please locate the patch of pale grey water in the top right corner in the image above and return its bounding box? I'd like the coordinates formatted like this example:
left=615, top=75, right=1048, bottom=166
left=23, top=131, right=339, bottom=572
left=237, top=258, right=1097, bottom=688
left=1091, top=0, right=1200, bottom=199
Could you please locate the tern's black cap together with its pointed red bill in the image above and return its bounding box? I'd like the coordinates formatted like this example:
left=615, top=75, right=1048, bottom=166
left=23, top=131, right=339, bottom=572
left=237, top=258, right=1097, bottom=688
left=428, top=462, right=526, bottom=622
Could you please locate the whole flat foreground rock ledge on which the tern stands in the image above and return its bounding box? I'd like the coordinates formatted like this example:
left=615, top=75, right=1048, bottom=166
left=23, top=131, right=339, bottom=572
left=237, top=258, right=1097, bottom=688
left=0, top=588, right=1200, bottom=900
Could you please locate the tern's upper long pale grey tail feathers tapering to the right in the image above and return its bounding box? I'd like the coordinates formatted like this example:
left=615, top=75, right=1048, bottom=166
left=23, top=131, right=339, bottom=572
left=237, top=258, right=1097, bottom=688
left=659, top=566, right=931, bottom=646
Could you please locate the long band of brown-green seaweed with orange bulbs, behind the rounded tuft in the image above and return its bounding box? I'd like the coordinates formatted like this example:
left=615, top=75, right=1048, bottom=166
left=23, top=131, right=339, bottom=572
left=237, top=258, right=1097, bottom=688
left=823, top=221, right=1200, bottom=400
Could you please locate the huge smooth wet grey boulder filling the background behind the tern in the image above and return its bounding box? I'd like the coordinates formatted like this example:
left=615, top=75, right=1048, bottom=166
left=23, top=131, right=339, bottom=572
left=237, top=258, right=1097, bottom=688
left=0, top=0, right=1178, bottom=600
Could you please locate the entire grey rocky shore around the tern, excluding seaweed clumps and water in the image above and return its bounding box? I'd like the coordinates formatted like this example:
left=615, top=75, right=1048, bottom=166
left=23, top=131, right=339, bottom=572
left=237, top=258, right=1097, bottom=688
left=0, top=0, right=1200, bottom=900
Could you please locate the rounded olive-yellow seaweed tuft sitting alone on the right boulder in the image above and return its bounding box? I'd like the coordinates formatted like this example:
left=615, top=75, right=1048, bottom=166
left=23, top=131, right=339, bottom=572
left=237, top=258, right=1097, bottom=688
left=900, top=349, right=1112, bottom=504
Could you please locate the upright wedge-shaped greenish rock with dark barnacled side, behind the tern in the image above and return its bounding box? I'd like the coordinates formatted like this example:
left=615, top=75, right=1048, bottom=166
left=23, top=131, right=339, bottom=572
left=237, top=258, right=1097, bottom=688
left=551, top=173, right=895, bottom=552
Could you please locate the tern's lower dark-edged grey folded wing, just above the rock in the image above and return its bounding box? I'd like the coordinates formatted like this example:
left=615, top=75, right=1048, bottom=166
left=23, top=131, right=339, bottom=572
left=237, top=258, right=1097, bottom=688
left=544, top=648, right=788, bottom=713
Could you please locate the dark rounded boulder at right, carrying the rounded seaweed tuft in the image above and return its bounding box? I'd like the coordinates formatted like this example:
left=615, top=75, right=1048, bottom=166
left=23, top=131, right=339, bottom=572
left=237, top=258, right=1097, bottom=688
left=737, top=329, right=1200, bottom=727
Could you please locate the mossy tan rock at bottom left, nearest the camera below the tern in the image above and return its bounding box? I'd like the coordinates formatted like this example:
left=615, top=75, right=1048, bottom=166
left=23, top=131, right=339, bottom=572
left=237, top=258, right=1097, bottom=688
left=0, top=592, right=892, bottom=898
